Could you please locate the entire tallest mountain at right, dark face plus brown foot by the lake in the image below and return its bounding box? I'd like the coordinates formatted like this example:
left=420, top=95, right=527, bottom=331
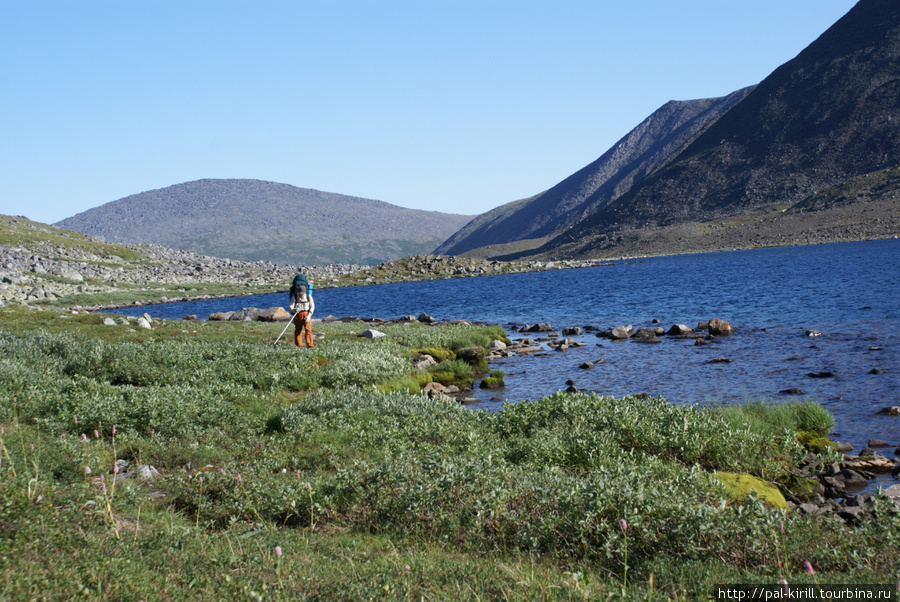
left=519, top=0, right=900, bottom=258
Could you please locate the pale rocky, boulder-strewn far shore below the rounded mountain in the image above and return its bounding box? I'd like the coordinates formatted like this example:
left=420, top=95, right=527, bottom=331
left=0, top=216, right=600, bottom=304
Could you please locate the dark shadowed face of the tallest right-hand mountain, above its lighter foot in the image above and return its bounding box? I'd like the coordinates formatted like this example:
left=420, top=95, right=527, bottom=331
left=536, top=0, right=900, bottom=257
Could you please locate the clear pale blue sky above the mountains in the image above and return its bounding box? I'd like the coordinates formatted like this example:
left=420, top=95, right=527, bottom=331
left=0, top=0, right=855, bottom=223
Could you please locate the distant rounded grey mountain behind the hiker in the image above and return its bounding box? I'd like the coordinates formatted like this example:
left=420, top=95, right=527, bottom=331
left=55, top=179, right=471, bottom=265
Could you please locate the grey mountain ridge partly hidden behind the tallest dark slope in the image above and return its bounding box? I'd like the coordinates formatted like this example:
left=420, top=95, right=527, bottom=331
left=435, top=88, right=752, bottom=255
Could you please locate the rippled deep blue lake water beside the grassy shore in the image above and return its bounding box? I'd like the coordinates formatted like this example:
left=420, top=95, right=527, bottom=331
left=119, top=239, right=900, bottom=468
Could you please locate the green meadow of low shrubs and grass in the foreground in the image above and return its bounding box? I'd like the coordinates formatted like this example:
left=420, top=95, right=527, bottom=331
left=0, top=307, right=900, bottom=600
